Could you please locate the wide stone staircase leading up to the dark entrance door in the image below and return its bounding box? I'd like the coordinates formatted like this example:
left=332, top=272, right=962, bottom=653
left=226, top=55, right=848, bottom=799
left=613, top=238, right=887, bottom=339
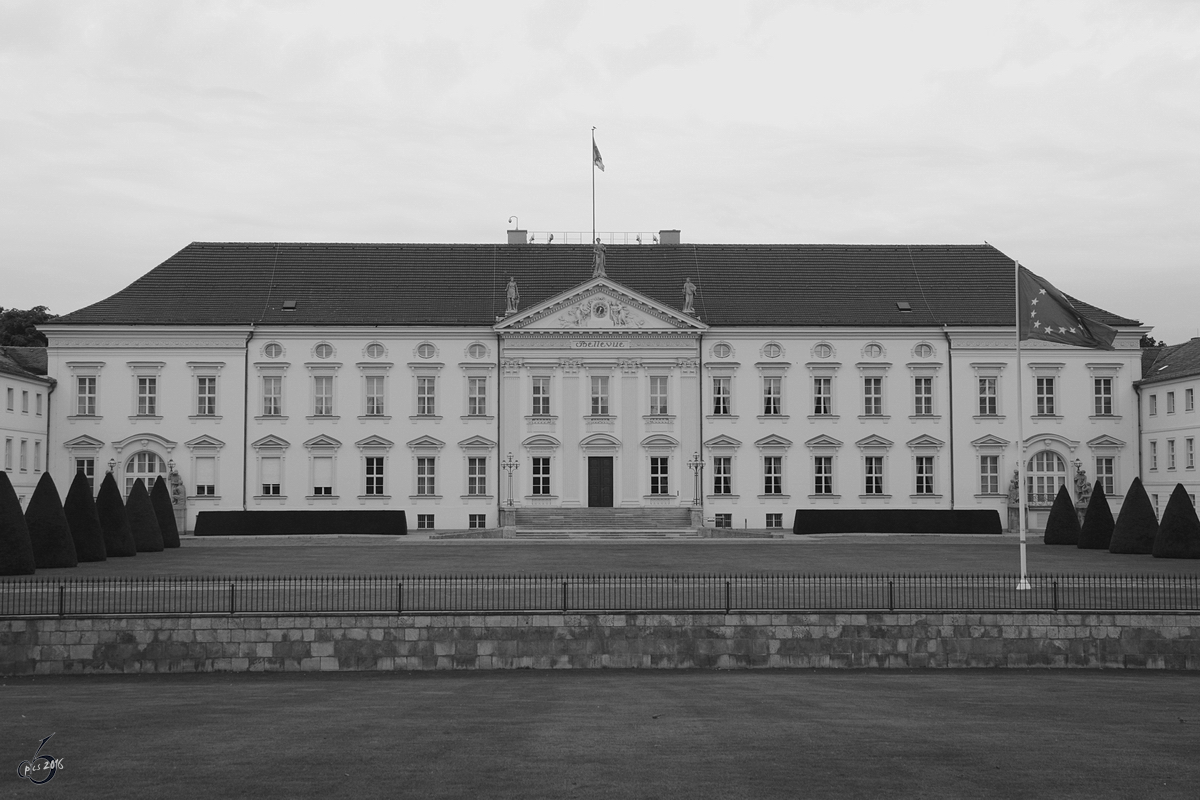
left=516, top=507, right=700, bottom=540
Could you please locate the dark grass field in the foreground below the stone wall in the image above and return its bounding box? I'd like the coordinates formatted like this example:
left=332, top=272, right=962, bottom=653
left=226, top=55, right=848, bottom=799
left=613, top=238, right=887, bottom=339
left=0, top=670, right=1200, bottom=798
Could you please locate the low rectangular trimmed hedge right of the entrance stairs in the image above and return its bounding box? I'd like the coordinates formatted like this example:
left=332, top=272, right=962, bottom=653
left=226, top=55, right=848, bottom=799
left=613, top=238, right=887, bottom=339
left=792, top=509, right=1003, bottom=536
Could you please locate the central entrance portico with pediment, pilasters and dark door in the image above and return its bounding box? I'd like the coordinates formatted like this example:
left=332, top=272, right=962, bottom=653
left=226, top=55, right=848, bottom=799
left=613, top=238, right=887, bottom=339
left=496, top=277, right=707, bottom=510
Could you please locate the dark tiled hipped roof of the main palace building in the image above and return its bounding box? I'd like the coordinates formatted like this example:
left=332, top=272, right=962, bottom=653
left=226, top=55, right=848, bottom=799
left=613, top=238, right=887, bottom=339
left=54, top=242, right=1138, bottom=326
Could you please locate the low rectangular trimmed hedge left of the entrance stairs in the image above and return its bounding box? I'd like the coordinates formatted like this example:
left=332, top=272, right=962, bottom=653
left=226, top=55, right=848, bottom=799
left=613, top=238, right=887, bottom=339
left=196, top=511, right=408, bottom=536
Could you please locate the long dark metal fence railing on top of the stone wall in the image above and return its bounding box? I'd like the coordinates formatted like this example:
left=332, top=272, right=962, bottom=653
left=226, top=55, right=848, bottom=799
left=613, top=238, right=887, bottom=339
left=0, top=575, right=1200, bottom=616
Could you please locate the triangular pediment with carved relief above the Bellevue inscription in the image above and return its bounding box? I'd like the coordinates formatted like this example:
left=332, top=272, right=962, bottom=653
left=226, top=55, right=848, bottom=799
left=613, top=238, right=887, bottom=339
left=496, top=278, right=708, bottom=332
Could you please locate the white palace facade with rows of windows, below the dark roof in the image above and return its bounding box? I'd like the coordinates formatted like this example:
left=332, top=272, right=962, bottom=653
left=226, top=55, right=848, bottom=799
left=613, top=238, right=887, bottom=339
left=39, top=278, right=1142, bottom=529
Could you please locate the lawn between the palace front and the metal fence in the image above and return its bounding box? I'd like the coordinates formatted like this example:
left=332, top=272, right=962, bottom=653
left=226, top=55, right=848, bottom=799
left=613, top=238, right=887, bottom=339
left=9, top=535, right=1200, bottom=578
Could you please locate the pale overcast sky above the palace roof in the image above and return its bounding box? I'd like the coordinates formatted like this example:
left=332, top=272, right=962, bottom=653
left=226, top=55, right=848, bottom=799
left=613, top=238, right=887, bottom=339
left=7, top=0, right=1200, bottom=343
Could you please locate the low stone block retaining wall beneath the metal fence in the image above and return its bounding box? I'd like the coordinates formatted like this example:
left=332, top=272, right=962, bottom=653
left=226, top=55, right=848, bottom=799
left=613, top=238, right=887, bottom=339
left=0, top=613, right=1200, bottom=675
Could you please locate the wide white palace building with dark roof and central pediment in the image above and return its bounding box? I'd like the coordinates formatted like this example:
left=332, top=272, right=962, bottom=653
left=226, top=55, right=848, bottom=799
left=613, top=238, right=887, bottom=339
left=42, top=230, right=1150, bottom=529
